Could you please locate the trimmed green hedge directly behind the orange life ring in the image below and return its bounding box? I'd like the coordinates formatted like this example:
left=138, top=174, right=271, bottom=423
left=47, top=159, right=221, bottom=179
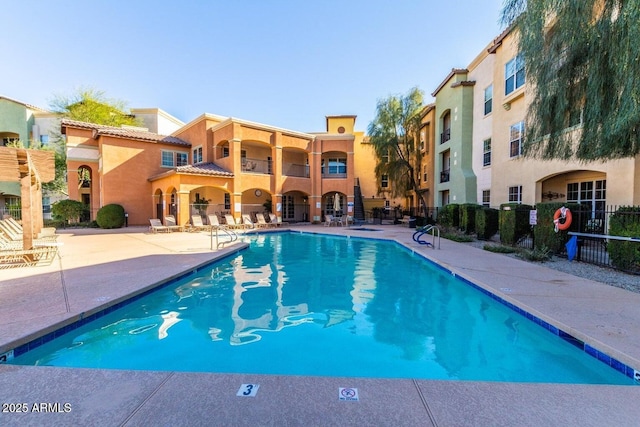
left=533, top=202, right=581, bottom=253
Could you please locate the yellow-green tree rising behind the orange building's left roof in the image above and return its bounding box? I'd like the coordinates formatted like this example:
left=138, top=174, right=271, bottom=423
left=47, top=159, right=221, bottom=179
left=43, top=89, right=140, bottom=194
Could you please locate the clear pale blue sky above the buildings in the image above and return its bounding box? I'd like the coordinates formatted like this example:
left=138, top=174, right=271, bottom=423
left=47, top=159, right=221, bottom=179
left=0, top=0, right=503, bottom=132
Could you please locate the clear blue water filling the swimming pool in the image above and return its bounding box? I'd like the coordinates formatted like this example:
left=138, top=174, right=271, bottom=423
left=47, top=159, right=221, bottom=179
left=11, top=233, right=633, bottom=384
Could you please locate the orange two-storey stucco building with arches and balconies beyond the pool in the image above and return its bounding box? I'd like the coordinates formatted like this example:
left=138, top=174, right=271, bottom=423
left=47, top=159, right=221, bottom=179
left=61, top=110, right=377, bottom=225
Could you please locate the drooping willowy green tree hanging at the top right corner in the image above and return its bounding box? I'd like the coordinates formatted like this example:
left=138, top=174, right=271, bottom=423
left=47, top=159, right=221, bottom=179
left=502, top=0, right=640, bottom=161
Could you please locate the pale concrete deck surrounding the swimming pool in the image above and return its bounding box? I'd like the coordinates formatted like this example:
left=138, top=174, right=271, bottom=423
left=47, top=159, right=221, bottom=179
left=0, top=226, right=640, bottom=426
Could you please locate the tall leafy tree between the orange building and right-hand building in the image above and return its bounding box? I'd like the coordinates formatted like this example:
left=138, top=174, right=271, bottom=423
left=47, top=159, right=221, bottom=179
left=367, top=88, right=427, bottom=217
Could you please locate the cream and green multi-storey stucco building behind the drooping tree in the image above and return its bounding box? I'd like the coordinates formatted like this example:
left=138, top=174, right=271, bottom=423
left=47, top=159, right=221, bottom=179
left=433, top=25, right=640, bottom=211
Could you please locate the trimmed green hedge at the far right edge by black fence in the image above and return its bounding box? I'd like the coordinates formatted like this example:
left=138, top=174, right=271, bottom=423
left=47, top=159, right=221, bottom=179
left=607, top=206, right=640, bottom=271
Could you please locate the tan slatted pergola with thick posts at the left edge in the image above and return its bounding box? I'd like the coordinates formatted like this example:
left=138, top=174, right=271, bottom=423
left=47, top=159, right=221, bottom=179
left=0, top=147, right=55, bottom=249
